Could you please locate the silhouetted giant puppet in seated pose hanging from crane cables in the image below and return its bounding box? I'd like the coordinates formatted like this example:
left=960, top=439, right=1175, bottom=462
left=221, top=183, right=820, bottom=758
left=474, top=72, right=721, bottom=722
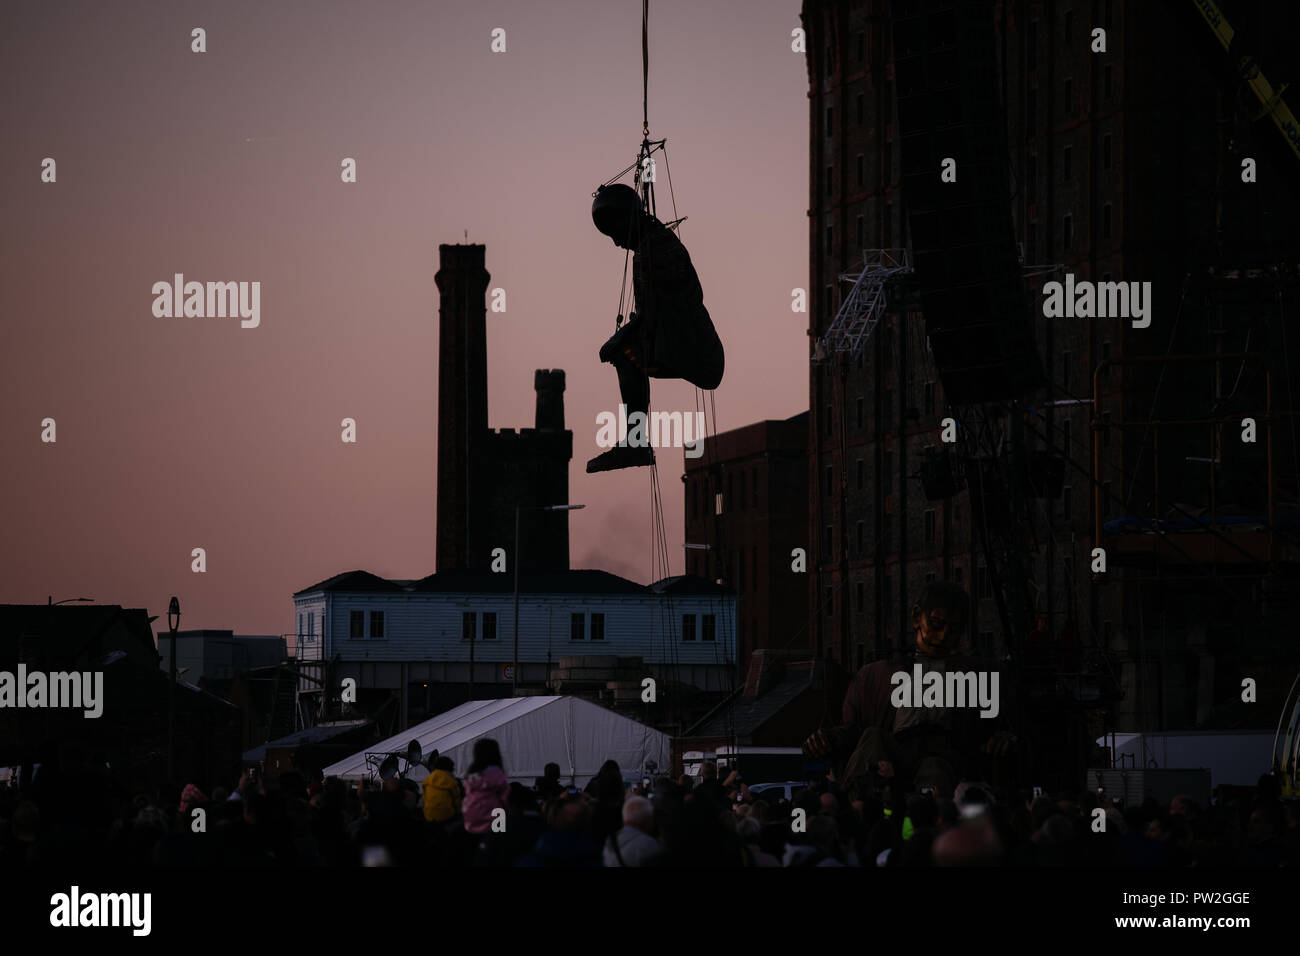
left=586, top=183, right=723, bottom=473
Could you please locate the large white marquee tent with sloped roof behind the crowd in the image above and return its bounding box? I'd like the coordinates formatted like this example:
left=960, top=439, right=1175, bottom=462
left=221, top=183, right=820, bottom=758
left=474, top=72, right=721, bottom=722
left=324, top=697, right=668, bottom=787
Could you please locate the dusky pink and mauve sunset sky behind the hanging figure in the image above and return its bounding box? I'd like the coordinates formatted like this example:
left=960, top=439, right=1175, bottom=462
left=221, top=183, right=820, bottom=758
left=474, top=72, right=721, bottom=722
left=0, top=0, right=809, bottom=633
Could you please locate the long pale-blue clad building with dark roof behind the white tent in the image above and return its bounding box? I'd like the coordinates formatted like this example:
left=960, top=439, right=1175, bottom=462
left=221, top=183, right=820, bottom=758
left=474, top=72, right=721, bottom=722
left=294, top=571, right=736, bottom=728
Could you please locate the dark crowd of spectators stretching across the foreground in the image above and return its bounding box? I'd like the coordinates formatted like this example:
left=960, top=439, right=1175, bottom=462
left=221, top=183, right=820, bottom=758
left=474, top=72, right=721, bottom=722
left=0, top=739, right=1300, bottom=868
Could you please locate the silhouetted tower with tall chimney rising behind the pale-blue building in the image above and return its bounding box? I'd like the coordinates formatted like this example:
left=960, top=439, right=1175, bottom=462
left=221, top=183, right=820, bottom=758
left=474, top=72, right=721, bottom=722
left=434, top=245, right=573, bottom=571
